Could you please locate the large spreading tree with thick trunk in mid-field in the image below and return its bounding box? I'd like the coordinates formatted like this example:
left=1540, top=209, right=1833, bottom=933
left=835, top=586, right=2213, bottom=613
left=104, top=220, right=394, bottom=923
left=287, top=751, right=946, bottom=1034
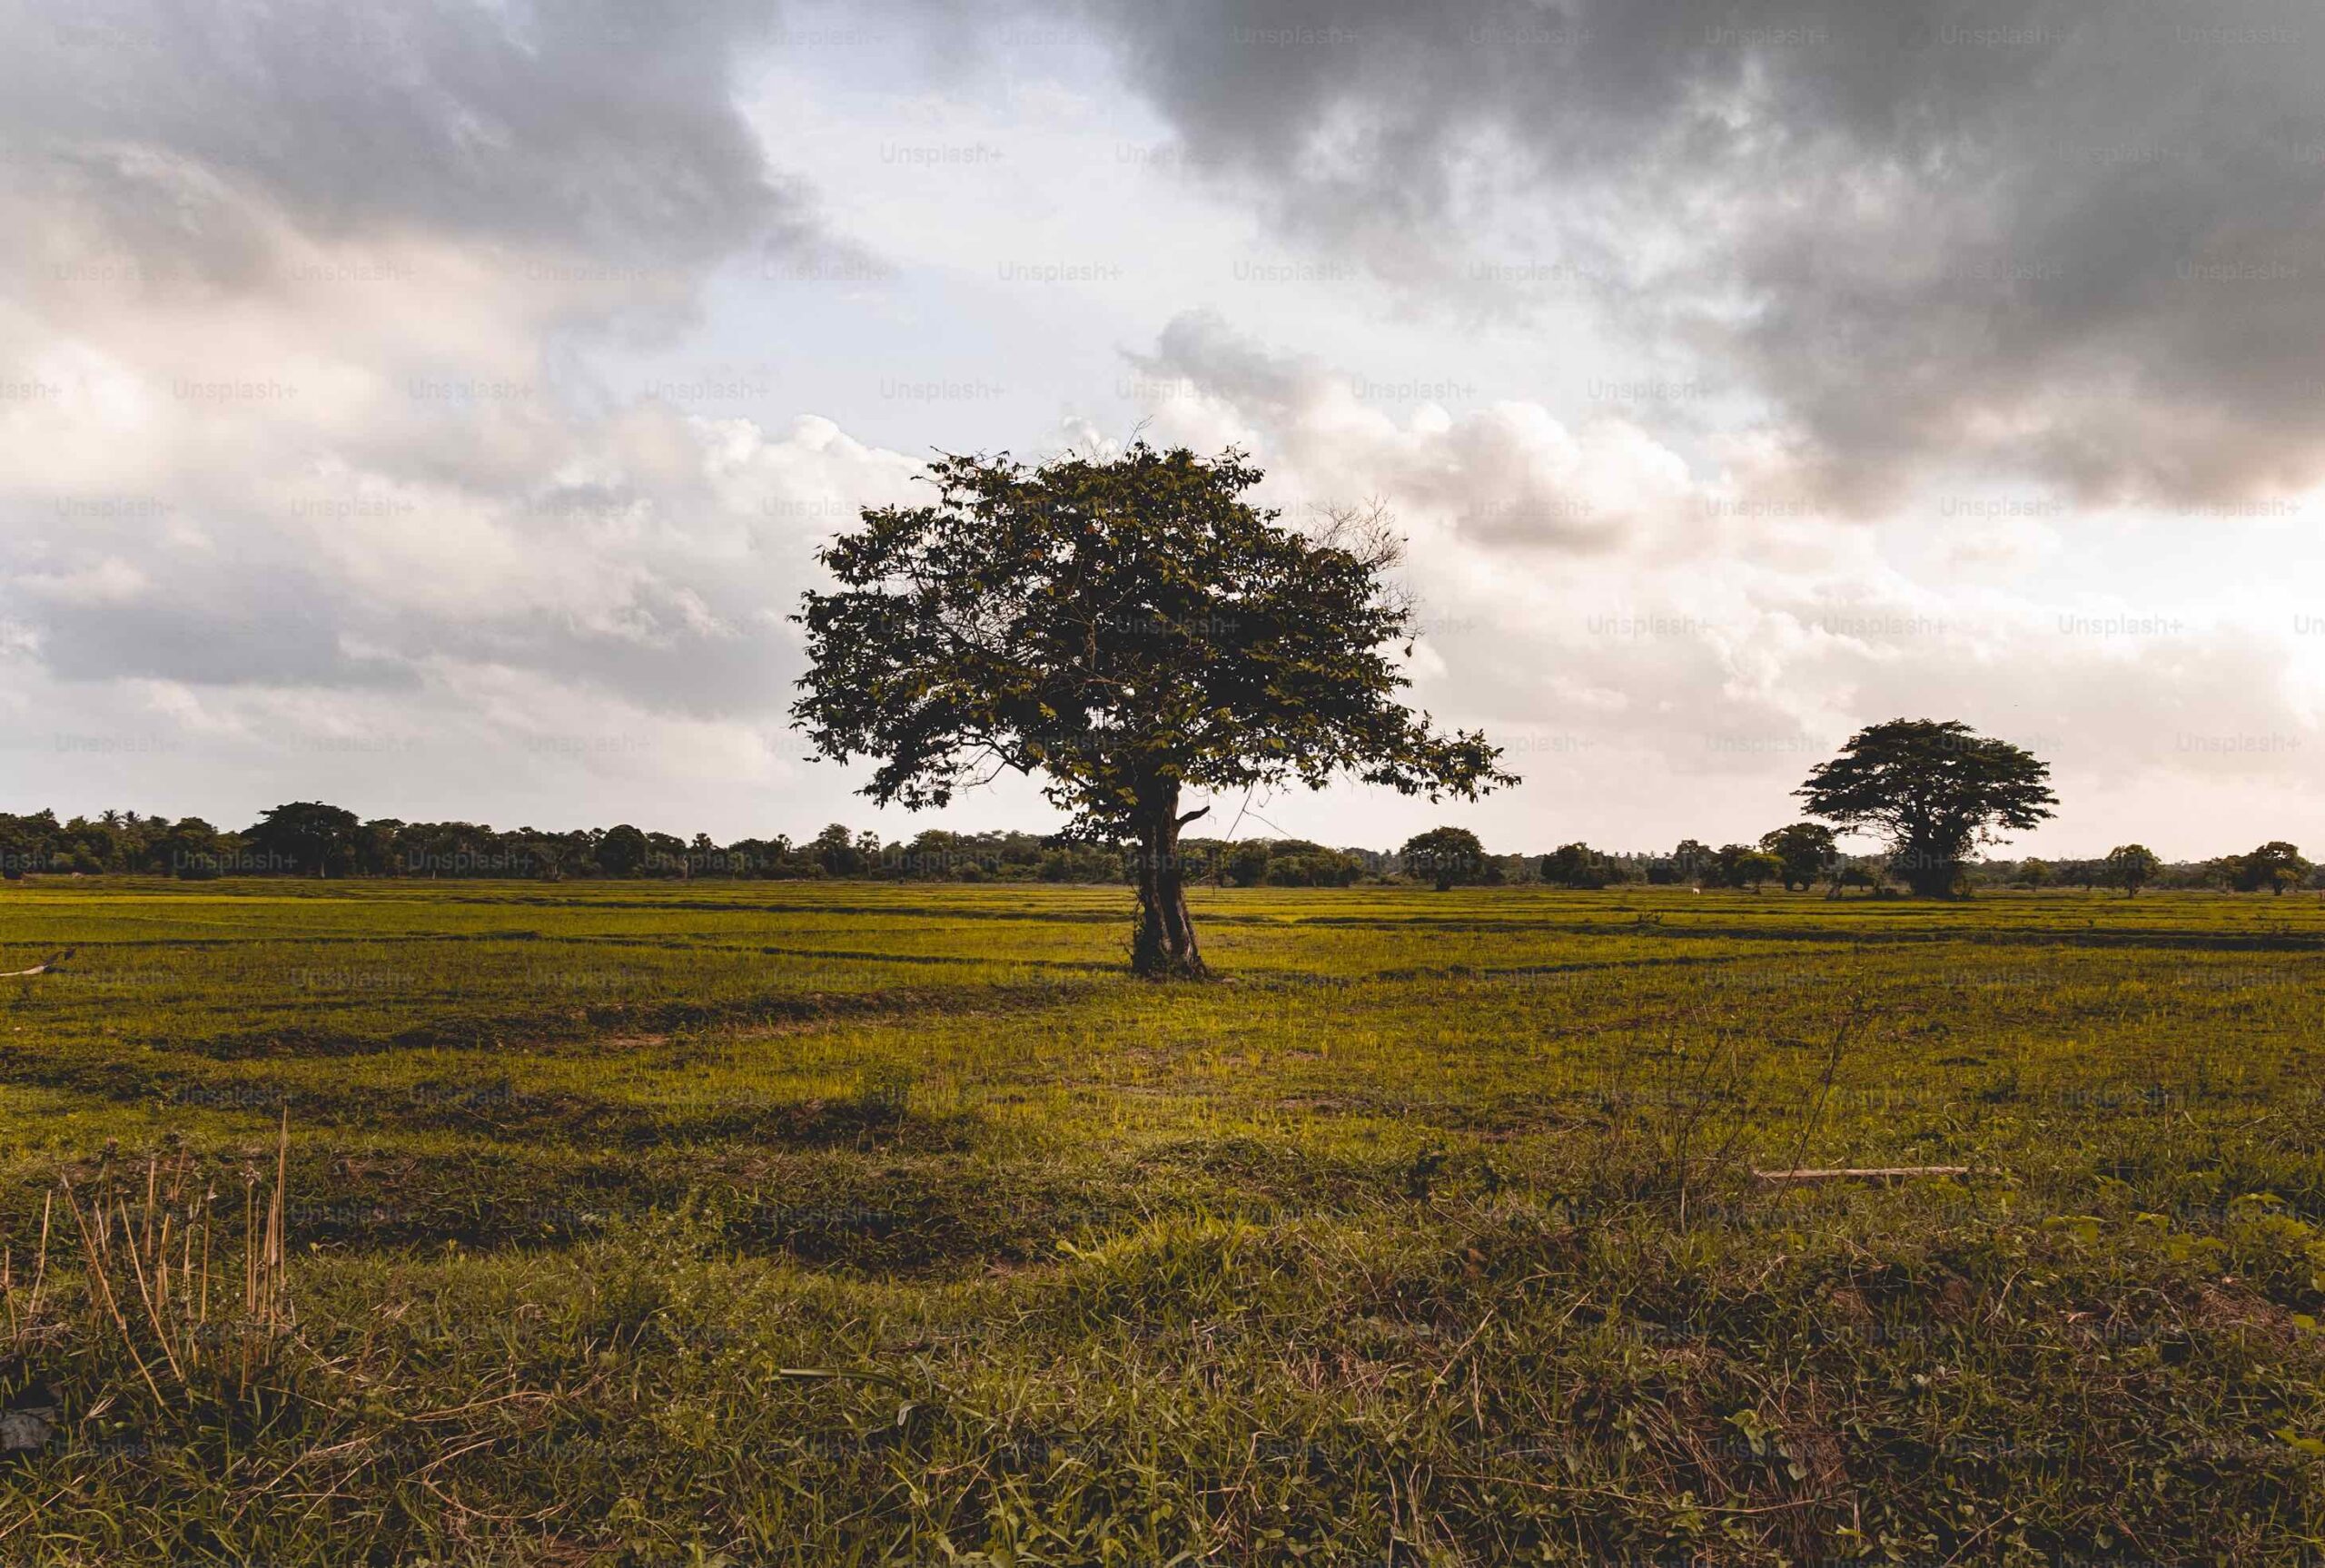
left=790, top=441, right=1516, bottom=978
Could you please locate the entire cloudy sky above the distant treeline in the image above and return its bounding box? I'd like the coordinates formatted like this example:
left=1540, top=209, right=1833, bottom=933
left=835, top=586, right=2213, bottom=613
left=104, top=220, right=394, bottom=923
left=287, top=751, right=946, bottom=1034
left=0, top=0, right=2325, bottom=857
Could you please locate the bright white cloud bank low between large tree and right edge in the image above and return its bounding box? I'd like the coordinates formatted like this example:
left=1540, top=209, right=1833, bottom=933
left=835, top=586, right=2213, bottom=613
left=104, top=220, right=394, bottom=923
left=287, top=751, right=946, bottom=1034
left=1106, top=319, right=2325, bottom=853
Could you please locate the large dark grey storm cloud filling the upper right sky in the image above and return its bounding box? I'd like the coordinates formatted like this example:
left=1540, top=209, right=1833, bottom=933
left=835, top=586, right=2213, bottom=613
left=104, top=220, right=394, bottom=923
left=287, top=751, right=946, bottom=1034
left=1088, top=0, right=2325, bottom=504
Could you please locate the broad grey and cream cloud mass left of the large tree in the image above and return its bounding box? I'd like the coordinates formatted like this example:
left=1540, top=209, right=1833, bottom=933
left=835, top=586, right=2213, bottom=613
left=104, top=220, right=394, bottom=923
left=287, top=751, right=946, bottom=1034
left=0, top=3, right=912, bottom=815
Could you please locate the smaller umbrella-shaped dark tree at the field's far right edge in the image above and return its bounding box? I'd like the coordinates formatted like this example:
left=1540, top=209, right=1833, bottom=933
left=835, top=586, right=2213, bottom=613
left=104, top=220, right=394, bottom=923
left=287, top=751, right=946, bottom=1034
left=1795, top=718, right=2058, bottom=899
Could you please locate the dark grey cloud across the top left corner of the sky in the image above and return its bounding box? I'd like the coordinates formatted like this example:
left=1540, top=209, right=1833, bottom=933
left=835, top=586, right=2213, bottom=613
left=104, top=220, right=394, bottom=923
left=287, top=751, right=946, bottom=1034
left=0, top=0, right=793, bottom=281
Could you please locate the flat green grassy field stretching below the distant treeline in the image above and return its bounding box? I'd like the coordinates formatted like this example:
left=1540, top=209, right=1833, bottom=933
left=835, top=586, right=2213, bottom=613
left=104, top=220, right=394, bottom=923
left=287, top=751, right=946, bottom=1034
left=0, top=881, right=2325, bottom=1565
